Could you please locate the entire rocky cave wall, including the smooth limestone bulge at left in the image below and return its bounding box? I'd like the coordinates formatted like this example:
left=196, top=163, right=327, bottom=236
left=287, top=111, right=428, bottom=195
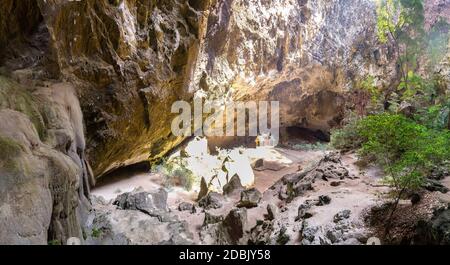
left=0, top=0, right=448, bottom=243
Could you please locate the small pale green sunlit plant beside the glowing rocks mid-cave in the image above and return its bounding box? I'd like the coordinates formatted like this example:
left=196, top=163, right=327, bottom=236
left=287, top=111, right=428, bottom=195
left=151, top=157, right=195, bottom=191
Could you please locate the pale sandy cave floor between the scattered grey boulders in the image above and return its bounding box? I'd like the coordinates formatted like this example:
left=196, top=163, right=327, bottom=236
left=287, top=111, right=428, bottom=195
left=92, top=145, right=398, bottom=244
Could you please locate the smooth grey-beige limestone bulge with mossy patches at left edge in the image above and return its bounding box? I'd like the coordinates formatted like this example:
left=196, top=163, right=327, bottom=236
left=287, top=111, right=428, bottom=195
left=0, top=77, right=93, bottom=244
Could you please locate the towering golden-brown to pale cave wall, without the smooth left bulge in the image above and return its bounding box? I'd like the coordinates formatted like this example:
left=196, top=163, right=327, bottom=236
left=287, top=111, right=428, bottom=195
left=0, top=0, right=448, bottom=177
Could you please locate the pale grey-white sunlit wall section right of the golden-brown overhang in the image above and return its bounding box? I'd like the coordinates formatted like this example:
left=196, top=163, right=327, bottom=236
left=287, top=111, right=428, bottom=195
left=192, top=0, right=396, bottom=132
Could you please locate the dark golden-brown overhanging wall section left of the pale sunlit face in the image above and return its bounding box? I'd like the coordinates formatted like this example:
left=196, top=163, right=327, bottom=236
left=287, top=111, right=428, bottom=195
left=31, top=0, right=213, bottom=175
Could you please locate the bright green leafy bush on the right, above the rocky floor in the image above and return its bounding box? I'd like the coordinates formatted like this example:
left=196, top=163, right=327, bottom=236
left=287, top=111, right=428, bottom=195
left=357, top=113, right=450, bottom=192
